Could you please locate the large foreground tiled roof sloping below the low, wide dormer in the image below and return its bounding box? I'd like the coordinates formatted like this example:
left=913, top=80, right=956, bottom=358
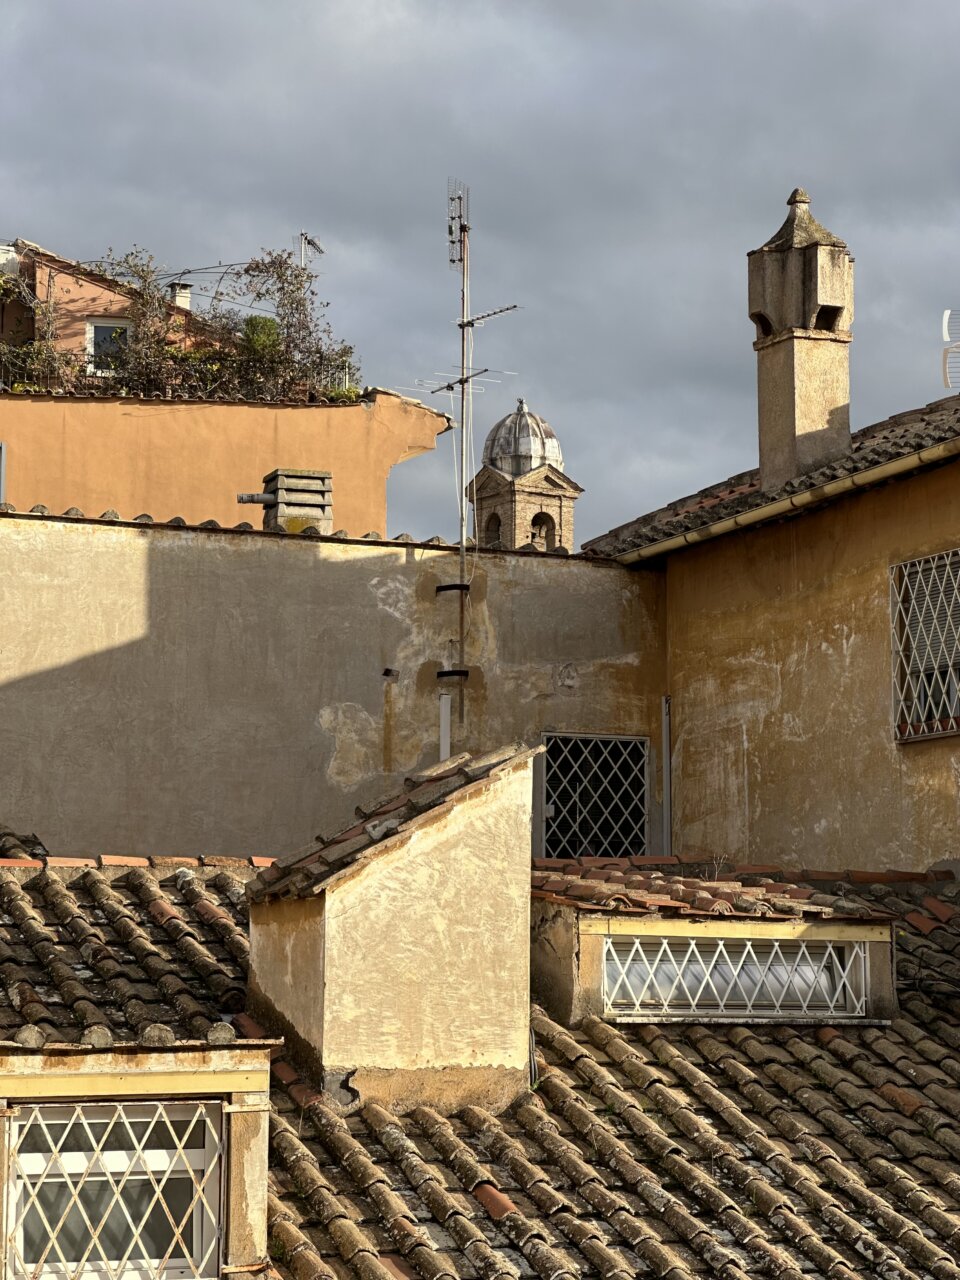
left=252, top=872, right=960, bottom=1280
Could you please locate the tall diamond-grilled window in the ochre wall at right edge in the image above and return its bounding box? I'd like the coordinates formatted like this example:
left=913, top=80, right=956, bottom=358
left=891, top=549, right=960, bottom=741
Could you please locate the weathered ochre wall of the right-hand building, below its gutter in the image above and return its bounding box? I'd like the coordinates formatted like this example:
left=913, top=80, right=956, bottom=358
left=667, top=466, right=960, bottom=869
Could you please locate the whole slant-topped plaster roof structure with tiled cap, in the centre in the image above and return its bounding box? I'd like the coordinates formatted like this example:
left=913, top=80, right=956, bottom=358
left=247, top=746, right=543, bottom=1114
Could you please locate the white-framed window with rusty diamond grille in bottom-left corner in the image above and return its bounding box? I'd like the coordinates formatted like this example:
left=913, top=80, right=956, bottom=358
left=6, top=1102, right=223, bottom=1280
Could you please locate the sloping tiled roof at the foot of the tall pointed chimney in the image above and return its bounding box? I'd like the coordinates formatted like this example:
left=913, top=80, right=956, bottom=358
left=584, top=396, right=960, bottom=556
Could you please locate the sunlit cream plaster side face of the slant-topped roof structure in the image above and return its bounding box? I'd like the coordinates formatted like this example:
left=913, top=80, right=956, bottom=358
left=323, top=759, right=532, bottom=1070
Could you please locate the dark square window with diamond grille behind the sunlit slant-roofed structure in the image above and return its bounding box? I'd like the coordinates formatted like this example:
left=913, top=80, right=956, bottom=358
left=544, top=733, right=648, bottom=858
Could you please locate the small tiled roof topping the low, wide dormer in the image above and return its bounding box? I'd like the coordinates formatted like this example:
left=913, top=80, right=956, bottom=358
left=532, top=858, right=890, bottom=920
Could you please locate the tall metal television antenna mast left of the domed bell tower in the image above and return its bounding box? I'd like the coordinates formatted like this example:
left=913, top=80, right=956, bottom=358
left=442, top=178, right=517, bottom=724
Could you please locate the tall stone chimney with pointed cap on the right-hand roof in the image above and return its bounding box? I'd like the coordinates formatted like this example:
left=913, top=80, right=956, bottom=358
left=748, top=188, right=854, bottom=492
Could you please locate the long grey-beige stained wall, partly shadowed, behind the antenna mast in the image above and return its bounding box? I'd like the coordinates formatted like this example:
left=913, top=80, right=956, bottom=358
left=0, top=513, right=664, bottom=854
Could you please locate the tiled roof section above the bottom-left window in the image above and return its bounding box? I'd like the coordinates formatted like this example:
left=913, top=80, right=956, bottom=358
left=0, top=829, right=268, bottom=1048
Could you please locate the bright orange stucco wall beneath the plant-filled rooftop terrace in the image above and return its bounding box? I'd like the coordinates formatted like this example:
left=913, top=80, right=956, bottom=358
left=0, top=393, right=445, bottom=538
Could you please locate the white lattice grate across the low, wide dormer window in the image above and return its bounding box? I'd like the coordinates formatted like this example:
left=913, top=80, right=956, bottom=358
left=603, top=936, right=867, bottom=1019
